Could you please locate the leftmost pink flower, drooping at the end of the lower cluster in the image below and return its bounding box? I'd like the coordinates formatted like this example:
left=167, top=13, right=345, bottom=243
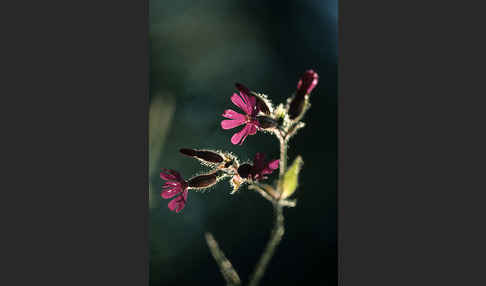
left=160, top=169, right=189, bottom=213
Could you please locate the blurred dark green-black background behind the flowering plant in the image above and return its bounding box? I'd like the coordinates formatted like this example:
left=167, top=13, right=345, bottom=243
left=149, top=0, right=338, bottom=286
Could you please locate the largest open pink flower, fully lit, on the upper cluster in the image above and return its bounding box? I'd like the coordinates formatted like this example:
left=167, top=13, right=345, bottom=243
left=221, top=83, right=259, bottom=145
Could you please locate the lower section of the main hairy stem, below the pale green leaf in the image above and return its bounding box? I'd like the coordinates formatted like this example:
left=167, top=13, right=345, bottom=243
left=248, top=203, right=285, bottom=286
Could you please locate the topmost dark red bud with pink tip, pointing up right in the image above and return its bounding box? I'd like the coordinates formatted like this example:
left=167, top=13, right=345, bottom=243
left=288, top=70, right=319, bottom=119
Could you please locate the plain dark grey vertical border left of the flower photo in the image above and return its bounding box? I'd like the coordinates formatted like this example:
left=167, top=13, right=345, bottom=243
left=0, top=0, right=149, bottom=286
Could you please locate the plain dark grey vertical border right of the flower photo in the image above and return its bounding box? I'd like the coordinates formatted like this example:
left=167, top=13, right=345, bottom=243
left=338, top=0, right=486, bottom=286
